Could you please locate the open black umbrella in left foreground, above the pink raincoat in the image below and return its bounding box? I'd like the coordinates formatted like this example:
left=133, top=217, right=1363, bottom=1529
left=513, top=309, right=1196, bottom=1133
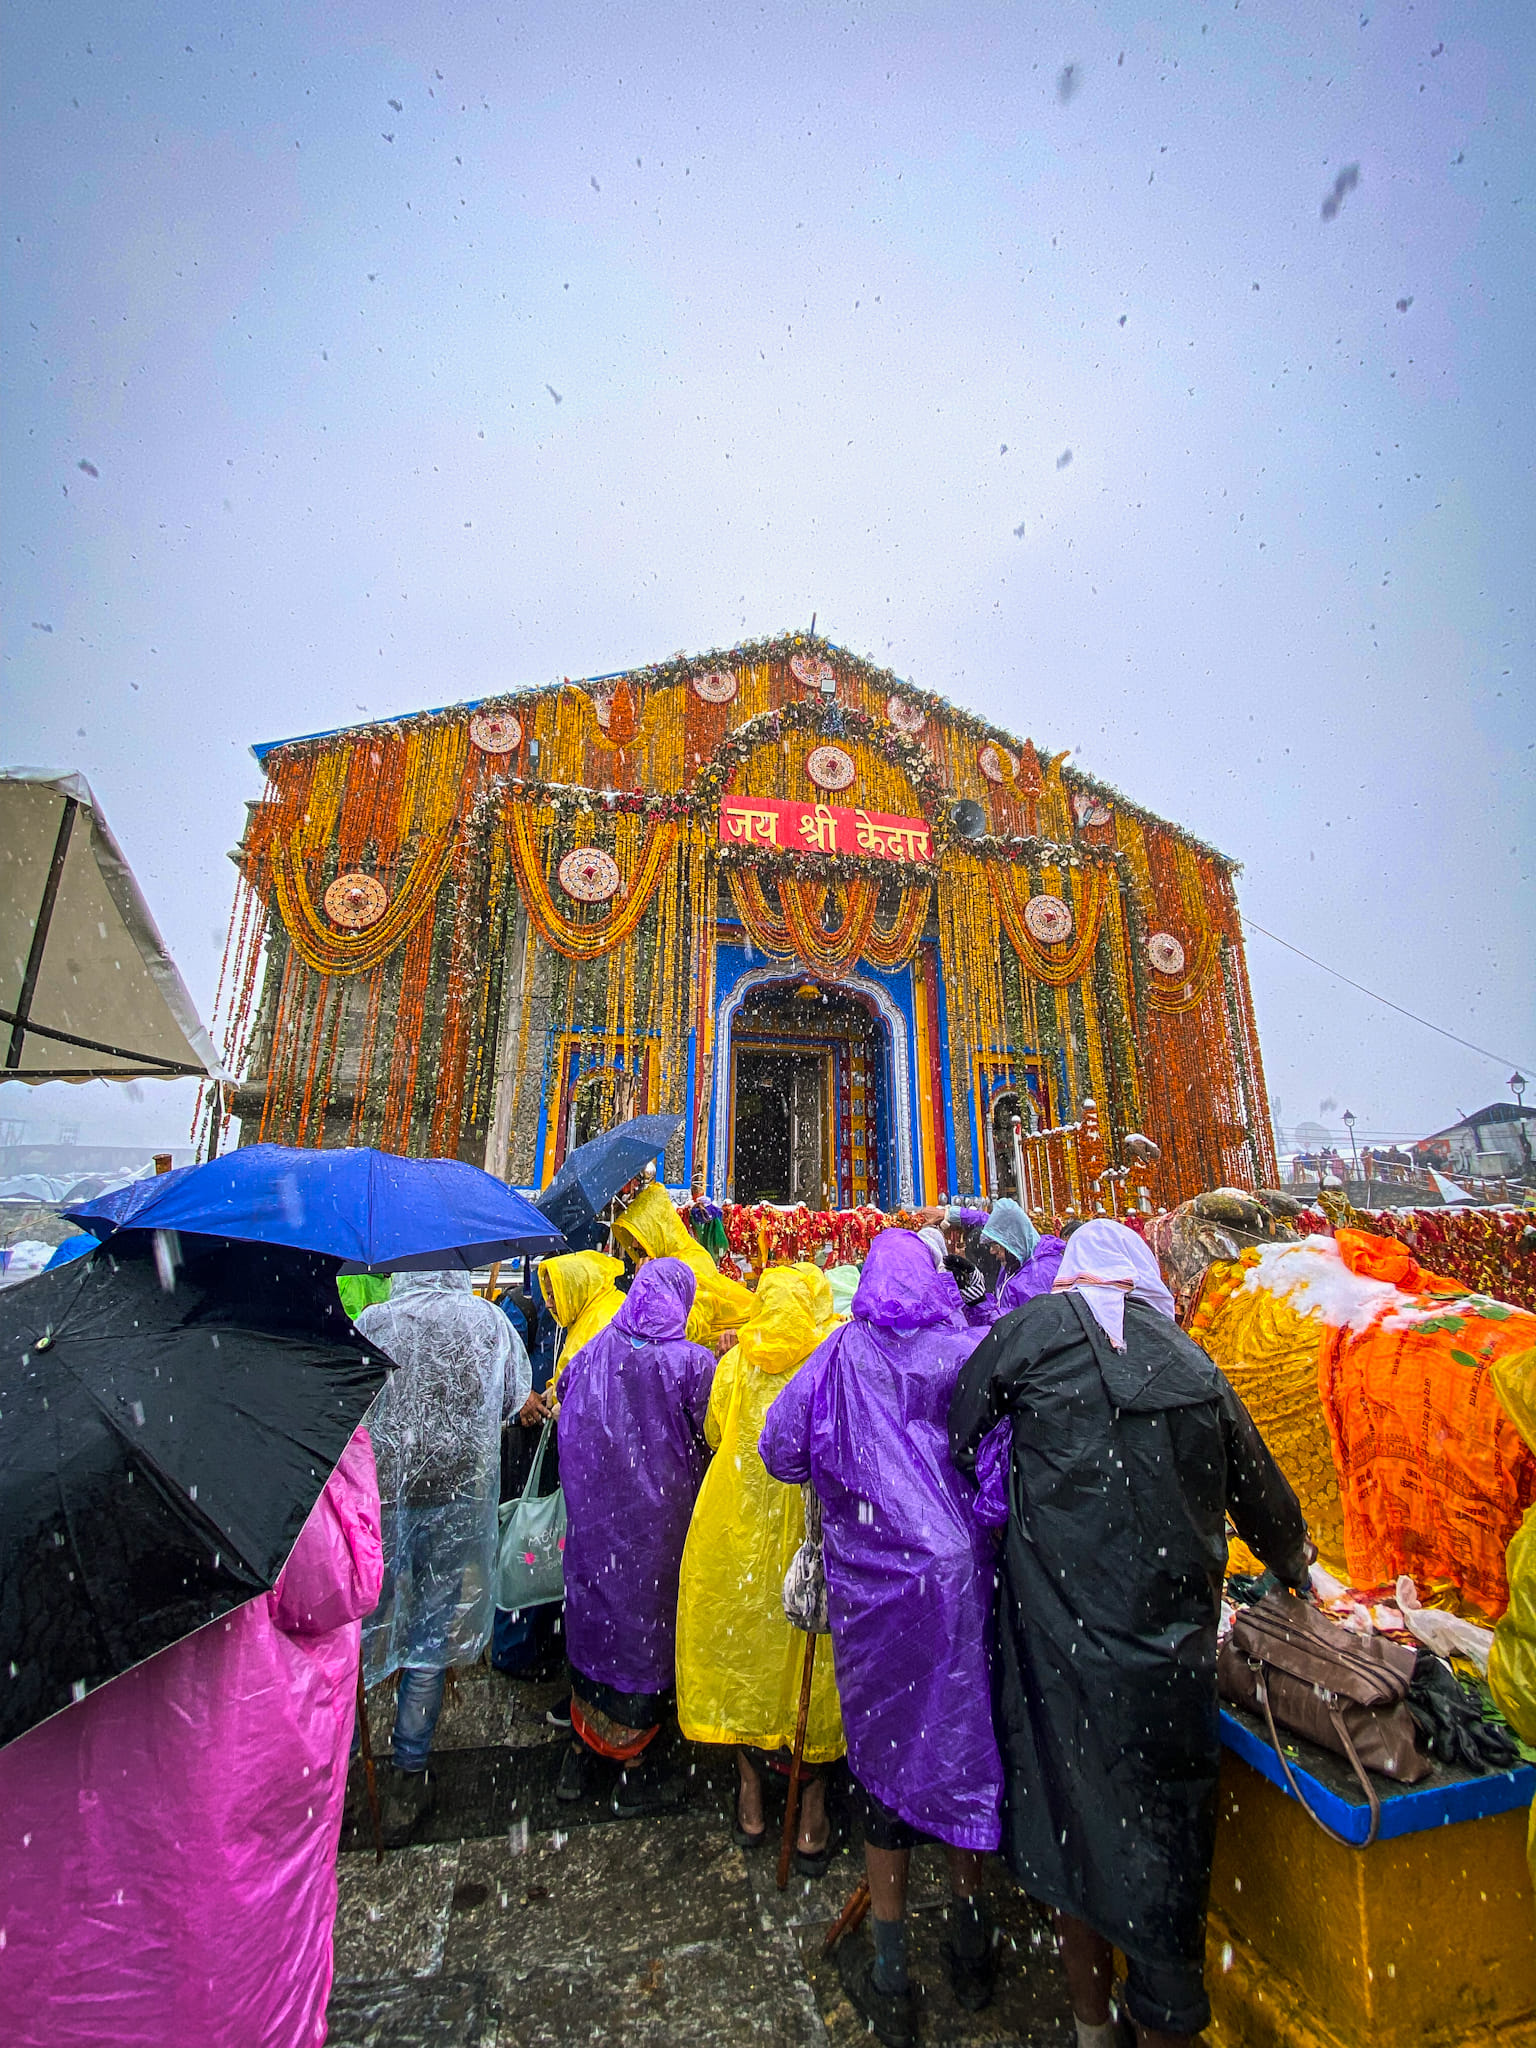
left=0, top=1231, right=389, bottom=1743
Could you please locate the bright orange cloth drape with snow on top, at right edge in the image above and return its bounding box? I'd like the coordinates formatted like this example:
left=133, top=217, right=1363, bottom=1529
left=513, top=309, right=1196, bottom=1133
left=1317, top=1231, right=1536, bottom=1620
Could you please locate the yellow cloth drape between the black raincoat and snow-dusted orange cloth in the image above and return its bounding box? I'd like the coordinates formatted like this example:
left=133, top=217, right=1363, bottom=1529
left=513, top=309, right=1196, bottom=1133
left=1190, top=1251, right=1350, bottom=1581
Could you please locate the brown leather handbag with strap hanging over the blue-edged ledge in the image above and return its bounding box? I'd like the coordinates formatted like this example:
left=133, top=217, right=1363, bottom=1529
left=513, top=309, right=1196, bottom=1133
left=1217, top=1593, right=1430, bottom=1849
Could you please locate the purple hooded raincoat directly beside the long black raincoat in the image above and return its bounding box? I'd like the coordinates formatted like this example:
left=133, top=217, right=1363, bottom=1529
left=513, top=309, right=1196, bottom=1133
left=758, top=1231, right=1001, bottom=1849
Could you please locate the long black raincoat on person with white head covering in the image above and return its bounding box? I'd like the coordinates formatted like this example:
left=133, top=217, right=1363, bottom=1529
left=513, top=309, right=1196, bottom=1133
left=950, top=1294, right=1307, bottom=1964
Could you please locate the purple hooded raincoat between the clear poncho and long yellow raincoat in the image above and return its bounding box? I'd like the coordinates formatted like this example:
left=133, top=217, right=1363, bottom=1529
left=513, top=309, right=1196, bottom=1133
left=559, top=1253, right=720, bottom=1696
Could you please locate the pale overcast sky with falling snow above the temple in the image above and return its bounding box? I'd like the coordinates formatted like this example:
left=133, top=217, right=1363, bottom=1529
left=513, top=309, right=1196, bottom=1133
left=0, top=0, right=1536, bottom=1143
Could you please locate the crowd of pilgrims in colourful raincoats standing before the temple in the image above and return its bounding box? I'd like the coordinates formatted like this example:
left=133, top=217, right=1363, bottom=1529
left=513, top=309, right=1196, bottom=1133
left=0, top=1182, right=1313, bottom=2048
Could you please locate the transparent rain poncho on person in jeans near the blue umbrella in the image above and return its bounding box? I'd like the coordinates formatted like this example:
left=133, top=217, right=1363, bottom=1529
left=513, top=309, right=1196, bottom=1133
left=356, top=1272, right=532, bottom=1686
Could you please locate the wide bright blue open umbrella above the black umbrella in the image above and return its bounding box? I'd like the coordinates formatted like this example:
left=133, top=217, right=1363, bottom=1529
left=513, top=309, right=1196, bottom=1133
left=66, top=1145, right=565, bottom=1272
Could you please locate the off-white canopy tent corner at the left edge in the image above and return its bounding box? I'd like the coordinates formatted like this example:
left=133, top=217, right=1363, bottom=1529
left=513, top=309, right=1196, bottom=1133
left=0, top=768, right=229, bottom=1081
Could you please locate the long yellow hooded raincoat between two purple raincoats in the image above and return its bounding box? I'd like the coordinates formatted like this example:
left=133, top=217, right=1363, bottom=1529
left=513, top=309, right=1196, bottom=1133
left=678, top=1266, right=846, bottom=1763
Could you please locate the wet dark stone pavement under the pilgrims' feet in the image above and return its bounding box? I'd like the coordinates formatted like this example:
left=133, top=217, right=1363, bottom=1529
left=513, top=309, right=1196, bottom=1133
left=330, top=1667, right=1075, bottom=2048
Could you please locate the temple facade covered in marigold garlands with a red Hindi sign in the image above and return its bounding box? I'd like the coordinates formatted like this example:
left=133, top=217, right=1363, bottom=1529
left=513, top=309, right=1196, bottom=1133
left=221, top=635, right=1274, bottom=1214
